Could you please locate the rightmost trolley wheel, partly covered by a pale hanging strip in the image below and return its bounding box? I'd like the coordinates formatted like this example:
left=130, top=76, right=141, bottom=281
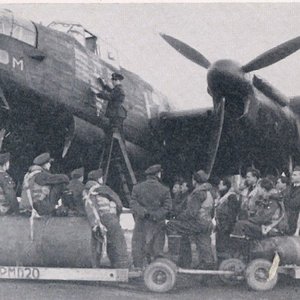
left=246, top=259, right=278, bottom=291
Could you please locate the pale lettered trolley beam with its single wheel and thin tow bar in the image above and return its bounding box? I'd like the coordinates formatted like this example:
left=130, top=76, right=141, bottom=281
left=0, top=258, right=239, bottom=292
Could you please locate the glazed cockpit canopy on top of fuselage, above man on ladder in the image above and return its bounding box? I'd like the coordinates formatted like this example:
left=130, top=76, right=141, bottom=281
left=48, top=22, right=120, bottom=69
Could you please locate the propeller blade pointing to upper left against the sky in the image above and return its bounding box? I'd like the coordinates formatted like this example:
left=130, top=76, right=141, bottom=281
left=160, top=33, right=210, bottom=69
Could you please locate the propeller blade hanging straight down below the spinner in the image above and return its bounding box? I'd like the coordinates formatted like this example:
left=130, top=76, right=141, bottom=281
left=207, top=97, right=225, bottom=177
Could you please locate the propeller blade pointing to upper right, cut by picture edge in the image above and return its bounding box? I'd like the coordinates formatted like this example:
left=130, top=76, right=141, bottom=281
left=242, top=36, right=300, bottom=73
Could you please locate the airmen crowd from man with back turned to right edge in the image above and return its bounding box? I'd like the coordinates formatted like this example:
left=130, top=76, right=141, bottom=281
left=130, top=165, right=300, bottom=270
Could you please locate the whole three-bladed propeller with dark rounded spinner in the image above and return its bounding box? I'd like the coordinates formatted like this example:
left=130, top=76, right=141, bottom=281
left=160, top=33, right=300, bottom=176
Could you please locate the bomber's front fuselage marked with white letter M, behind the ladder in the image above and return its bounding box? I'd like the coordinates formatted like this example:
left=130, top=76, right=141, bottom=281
left=0, top=10, right=170, bottom=196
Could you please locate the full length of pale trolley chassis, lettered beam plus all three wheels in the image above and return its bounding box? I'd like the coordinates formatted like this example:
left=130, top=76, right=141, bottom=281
left=0, top=258, right=300, bottom=293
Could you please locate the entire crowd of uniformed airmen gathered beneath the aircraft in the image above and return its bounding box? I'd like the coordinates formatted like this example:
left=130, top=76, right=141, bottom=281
left=0, top=148, right=300, bottom=269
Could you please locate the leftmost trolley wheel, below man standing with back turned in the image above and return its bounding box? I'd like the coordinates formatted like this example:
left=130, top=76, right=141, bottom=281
left=144, top=258, right=177, bottom=293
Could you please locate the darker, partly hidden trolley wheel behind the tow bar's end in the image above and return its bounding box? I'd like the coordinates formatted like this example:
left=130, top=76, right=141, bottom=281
left=219, top=258, right=246, bottom=285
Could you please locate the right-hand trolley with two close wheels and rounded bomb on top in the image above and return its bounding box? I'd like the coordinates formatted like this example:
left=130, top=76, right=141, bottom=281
left=219, top=236, right=300, bottom=291
